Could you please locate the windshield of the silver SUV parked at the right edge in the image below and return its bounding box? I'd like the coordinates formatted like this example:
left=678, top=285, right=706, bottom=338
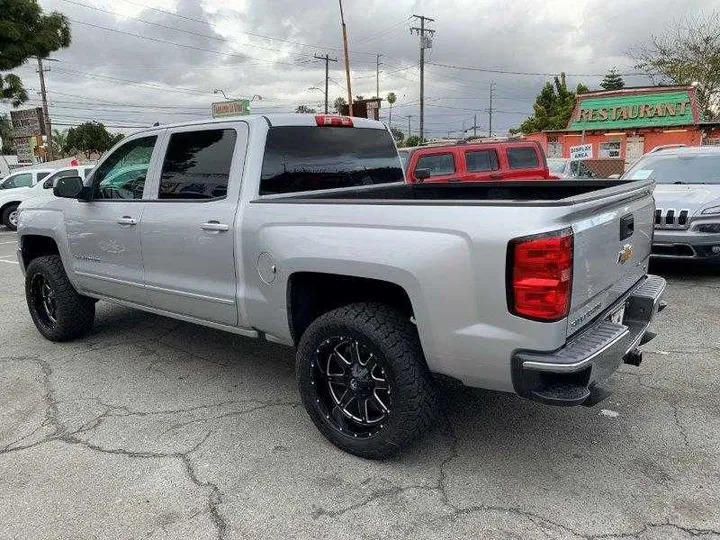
left=623, top=152, right=720, bottom=184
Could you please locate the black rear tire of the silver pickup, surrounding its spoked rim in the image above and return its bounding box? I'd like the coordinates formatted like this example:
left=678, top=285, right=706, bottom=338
left=296, top=303, right=436, bottom=459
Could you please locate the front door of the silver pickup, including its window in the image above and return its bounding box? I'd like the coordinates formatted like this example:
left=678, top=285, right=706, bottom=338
left=64, top=135, right=159, bottom=304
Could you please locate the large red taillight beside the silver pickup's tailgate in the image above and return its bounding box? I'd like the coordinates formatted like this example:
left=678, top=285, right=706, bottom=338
left=508, top=229, right=573, bottom=322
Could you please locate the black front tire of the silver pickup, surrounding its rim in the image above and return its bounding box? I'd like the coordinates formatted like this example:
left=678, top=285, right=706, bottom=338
left=25, top=255, right=95, bottom=341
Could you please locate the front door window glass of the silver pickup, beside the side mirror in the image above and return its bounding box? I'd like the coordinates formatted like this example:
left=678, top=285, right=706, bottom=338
left=93, top=135, right=157, bottom=200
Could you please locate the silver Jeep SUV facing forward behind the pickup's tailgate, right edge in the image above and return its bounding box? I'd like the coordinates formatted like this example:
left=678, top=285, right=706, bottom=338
left=623, top=146, right=720, bottom=261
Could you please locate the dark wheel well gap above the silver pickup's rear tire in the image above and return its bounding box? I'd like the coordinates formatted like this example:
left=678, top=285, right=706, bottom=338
left=288, top=272, right=413, bottom=344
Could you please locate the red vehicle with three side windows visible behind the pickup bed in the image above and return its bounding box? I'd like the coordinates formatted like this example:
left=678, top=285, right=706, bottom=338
left=398, top=141, right=554, bottom=184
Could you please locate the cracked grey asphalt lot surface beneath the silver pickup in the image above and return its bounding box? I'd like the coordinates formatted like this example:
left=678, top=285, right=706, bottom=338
left=0, top=231, right=720, bottom=540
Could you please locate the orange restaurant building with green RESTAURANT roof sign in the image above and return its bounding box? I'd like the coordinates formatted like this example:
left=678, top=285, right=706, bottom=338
left=527, top=86, right=720, bottom=164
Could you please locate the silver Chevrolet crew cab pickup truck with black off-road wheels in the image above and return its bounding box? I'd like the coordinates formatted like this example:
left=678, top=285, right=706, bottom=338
left=18, top=114, right=665, bottom=458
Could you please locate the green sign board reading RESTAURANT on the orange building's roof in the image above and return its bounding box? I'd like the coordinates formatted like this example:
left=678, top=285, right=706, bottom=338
left=570, top=90, right=695, bottom=130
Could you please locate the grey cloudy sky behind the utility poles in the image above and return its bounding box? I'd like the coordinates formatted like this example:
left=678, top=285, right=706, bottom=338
left=5, top=0, right=720, bottom=136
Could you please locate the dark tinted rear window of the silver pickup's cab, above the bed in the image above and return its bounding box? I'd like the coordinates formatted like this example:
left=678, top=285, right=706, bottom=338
left=260, top=126, right=404, bottom=195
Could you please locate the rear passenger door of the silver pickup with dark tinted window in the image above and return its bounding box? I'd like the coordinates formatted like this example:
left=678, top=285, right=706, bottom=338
left=141, top=122, right=248, bottom=325
